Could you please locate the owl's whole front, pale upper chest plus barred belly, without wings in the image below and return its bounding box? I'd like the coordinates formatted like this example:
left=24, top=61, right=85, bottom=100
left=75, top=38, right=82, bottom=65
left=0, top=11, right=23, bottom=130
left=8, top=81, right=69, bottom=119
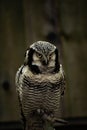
left=22, top=65, right=64, bottom=116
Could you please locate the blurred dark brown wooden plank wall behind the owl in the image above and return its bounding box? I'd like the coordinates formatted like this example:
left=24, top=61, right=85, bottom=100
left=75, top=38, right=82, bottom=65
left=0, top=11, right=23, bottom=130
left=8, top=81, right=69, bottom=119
left=0, top=0, right=87, bottom=128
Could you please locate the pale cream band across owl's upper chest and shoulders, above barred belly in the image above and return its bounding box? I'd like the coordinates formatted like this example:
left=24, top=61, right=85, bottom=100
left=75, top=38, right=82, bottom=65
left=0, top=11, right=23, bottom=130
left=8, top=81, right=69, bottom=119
left=16, top=64, right=65, bottom=95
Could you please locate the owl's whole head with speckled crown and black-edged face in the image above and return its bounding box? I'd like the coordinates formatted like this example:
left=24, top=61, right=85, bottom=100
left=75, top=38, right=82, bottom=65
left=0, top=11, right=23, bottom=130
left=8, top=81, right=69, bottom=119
left=24, top=41, right=60, bottom=74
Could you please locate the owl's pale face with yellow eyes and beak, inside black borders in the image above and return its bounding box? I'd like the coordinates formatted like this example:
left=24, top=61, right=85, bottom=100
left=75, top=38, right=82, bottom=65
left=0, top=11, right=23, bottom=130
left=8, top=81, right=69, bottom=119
left=32, top=52, right=56, bottom=73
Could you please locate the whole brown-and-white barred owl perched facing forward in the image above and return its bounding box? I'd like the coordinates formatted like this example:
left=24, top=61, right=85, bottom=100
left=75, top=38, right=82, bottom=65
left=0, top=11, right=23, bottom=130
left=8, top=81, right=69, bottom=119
left=16, top=41, right=65, bottom=130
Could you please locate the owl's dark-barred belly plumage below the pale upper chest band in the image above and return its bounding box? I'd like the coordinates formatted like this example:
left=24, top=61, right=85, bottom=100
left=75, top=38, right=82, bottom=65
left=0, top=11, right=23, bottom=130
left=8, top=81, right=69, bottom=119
left=23, top=74, right=61, bottom=116
